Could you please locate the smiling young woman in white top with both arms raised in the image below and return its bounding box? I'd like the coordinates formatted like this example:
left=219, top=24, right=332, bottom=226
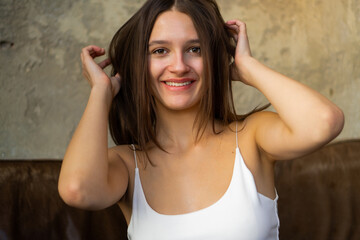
left=59, top=0, right=344, bottom=239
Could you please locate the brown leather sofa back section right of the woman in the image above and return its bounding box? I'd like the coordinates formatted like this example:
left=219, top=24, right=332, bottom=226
left=275, top=140, right=360, bottom=240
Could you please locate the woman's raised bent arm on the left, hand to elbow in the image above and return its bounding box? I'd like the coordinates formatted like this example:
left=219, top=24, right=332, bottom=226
left=58, top=46, right=128, bottom=209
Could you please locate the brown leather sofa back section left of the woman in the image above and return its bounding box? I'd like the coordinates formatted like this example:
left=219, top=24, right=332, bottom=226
left=0, top=160, right=127, bottom=240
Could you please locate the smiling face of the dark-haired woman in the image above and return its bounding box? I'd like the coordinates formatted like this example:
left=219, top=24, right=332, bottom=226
left=149, top=11, right=203, bottom=110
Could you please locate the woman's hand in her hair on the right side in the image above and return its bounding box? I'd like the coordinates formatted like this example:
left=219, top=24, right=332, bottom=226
left=226, top=20, right=252, bottom=85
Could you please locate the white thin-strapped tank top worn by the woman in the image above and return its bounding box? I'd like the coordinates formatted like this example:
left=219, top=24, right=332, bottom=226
left=128, top=124, right=280, bottom=240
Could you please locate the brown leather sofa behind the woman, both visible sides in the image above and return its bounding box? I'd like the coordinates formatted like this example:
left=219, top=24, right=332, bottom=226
left=0, top=140, right=360, bottom=240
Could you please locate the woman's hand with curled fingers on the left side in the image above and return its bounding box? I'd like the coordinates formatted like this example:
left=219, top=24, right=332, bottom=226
left=81, top=45, right=120, bottom=98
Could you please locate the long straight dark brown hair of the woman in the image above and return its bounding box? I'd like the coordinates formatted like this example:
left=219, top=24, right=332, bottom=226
left=109, top=0, right=268, bottom=163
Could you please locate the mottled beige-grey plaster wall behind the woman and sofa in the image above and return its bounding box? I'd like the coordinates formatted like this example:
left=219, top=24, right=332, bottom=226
left=0, top=0, right=360, bottom=158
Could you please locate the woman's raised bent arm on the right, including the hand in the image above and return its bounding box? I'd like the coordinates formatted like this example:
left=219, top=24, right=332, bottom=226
left=227, top=20, right=344, bottom=160
